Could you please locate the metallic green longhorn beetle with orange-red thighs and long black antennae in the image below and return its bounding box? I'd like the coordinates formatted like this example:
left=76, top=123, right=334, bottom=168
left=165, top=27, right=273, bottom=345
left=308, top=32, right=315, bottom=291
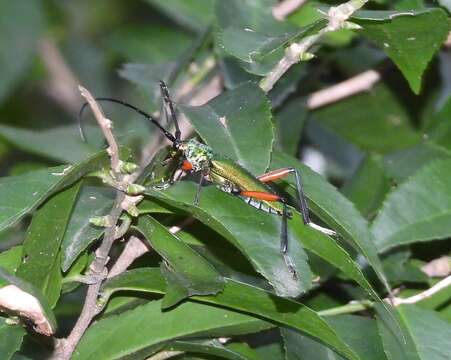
left=79, top=81, right=336, bottom=277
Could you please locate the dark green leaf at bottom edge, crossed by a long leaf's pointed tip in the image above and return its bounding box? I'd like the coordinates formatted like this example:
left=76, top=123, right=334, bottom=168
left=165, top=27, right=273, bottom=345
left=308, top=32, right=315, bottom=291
left=281, top=315, right=385, bottom=360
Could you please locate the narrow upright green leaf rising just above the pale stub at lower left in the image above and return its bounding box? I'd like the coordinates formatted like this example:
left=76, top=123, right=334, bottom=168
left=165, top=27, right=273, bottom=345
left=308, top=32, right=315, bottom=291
left=17, top=183, right=81, bottom=308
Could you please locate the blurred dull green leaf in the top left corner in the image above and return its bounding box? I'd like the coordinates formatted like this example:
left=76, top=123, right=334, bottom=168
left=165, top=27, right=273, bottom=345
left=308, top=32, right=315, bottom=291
left=0, top=0, right=44, bottom=102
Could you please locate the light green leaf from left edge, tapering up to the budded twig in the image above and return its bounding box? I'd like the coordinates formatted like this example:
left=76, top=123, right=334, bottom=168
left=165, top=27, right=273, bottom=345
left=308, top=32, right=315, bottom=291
left=0, top=151, right=128, bottom=231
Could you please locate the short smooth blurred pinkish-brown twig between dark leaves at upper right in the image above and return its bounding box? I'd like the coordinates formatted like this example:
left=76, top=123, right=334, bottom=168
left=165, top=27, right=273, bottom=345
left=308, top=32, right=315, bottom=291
left=307, top=70, right=381, bottom=110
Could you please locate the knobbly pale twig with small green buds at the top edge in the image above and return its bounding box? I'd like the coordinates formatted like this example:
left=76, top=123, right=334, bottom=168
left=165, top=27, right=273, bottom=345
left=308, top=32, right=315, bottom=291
left=260, top=0, right=368, bottom=92
